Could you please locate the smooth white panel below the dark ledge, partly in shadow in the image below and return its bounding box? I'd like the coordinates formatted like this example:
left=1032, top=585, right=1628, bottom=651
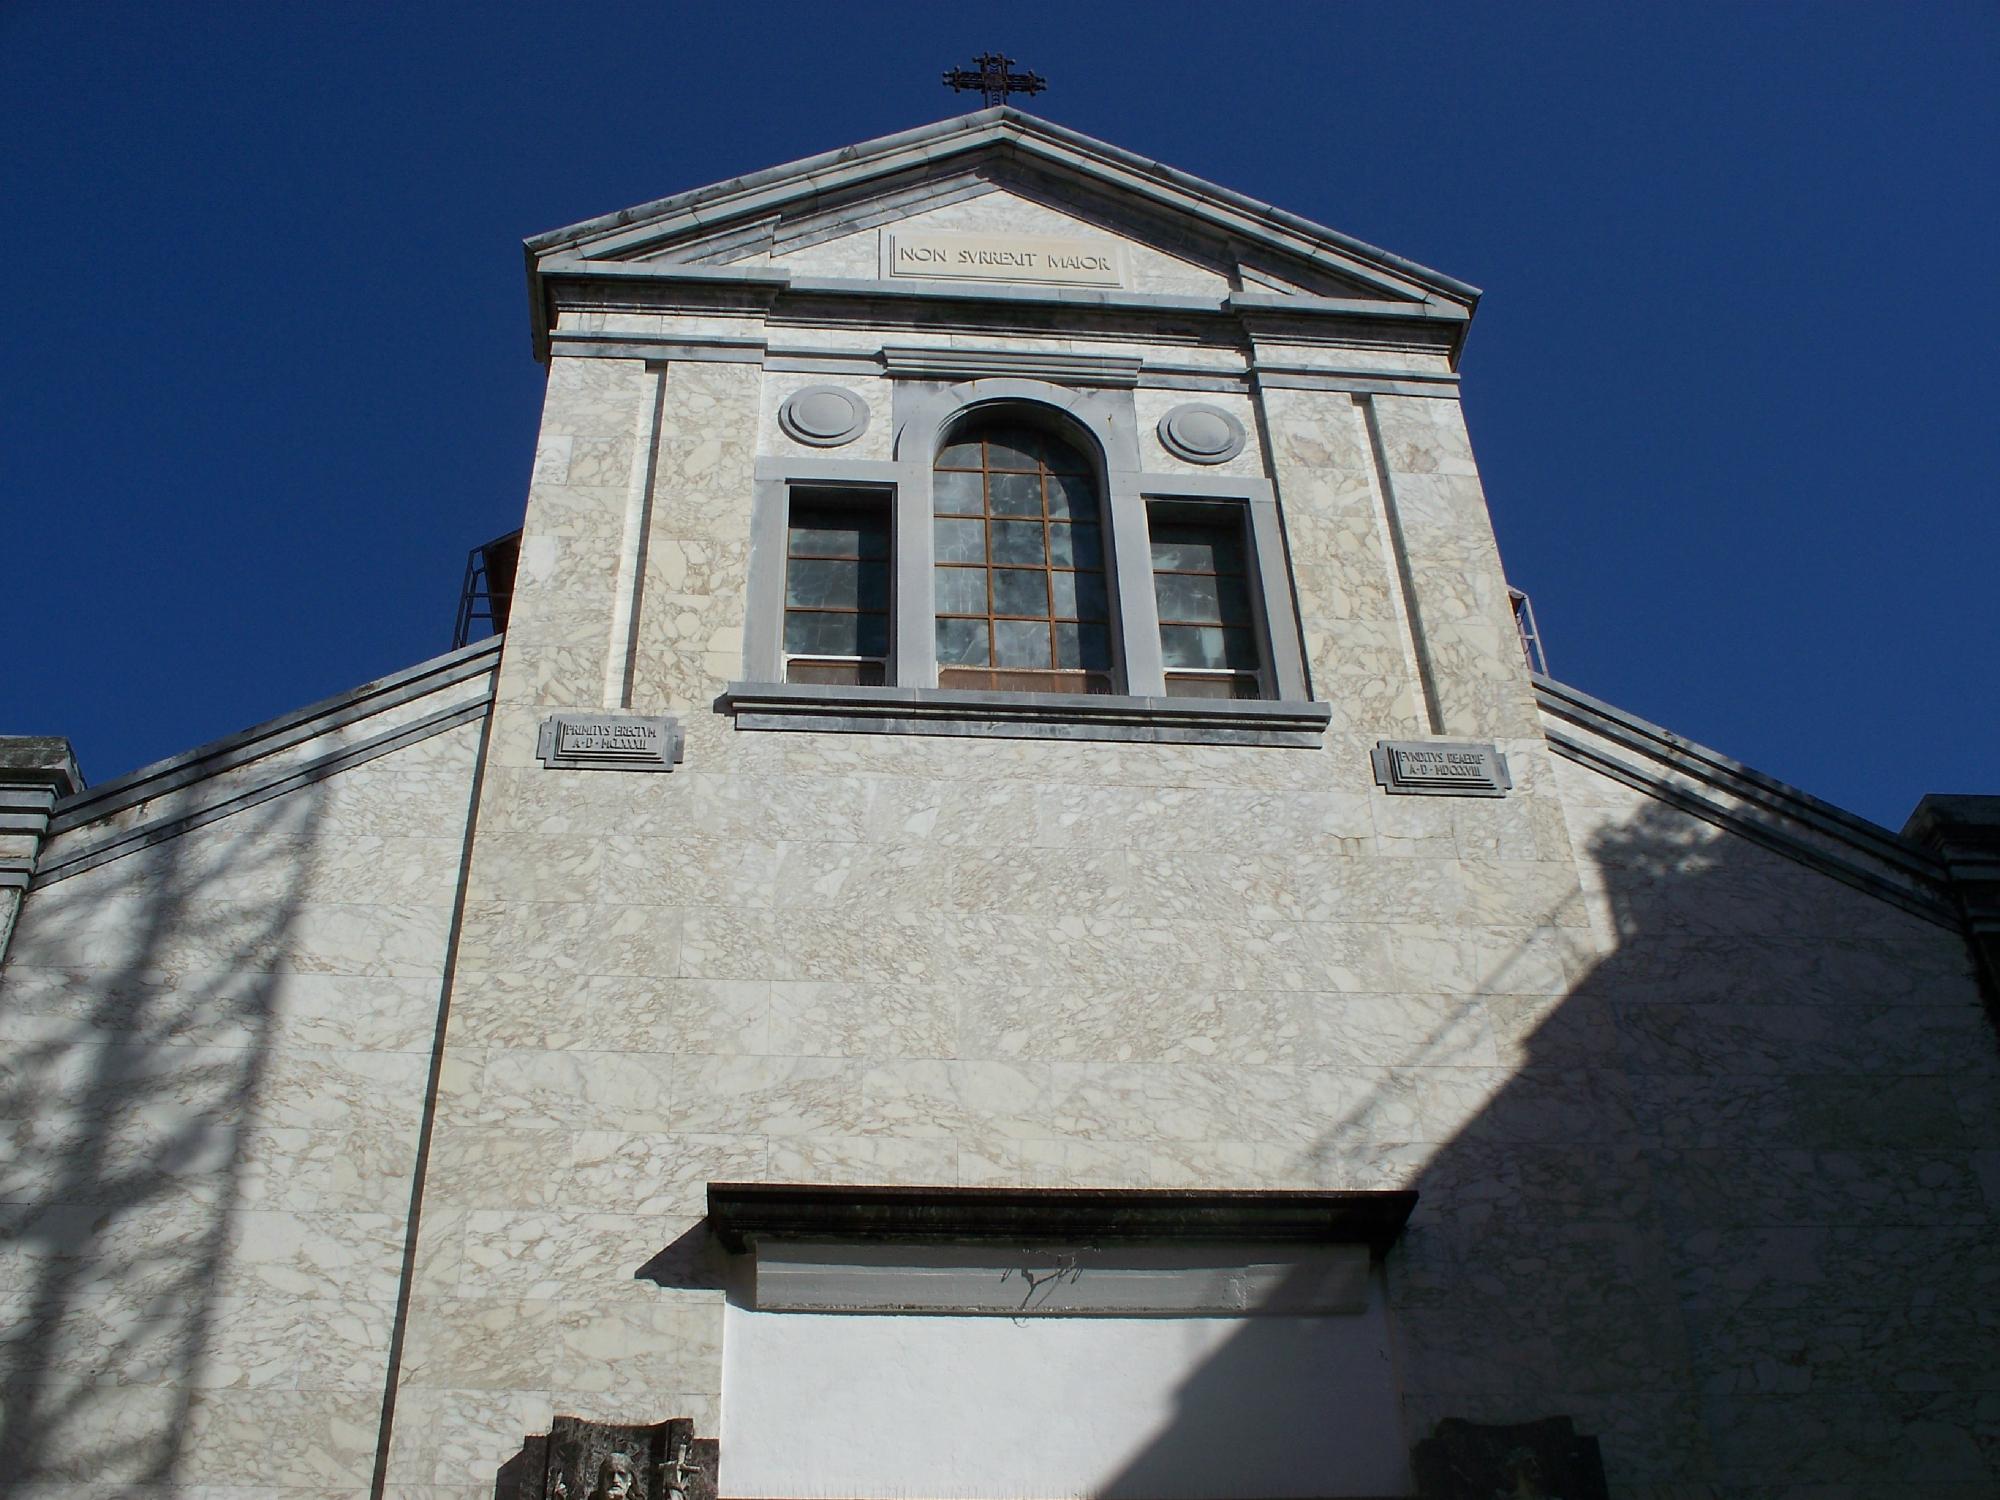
left=720, top=1274, right=1410, bottom=1500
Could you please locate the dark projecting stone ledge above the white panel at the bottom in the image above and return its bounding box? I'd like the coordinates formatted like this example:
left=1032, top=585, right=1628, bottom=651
left=708, top=1182, right=1416, bottom=1258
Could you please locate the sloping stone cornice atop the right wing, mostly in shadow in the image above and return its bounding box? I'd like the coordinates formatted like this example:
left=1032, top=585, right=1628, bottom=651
left=1534, top=676, right=1960, bottom=930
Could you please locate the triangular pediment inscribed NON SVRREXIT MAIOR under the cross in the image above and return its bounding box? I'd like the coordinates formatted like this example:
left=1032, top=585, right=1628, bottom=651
left=528, top=108, right=1478, bottom=312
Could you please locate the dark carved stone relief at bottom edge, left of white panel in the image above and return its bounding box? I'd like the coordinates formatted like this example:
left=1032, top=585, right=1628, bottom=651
left=494, top=1416, right=716, bottom=1500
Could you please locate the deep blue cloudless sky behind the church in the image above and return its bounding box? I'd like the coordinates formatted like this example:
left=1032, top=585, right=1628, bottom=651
left=0, top=0, right=2000, bottom=826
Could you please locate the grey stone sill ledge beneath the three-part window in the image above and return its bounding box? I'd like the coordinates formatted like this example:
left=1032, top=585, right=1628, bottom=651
left=716, top=682, right=1332, bottom=750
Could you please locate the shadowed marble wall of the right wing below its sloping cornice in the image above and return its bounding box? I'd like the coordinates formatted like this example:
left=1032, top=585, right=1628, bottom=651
left=1536, top=760, right=2000, bottom=1496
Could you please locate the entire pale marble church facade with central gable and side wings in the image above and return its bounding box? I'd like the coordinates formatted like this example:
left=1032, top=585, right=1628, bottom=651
left=0, top=108, right=2000, bottom=1500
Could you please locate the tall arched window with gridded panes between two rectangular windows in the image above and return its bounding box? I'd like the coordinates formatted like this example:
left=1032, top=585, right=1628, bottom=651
left=932, top=416, right=1112, bottom=692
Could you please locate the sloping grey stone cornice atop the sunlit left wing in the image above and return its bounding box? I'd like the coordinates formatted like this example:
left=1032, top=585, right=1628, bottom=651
left=50, top=636, right=504, bottom=832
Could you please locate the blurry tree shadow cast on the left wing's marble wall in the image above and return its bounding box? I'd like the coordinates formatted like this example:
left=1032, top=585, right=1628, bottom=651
left=0, top=784, right=324, bottom=1496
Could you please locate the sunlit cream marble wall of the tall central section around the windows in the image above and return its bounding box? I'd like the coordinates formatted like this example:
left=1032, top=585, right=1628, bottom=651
left=378, top=209, right=1640, bottom=1496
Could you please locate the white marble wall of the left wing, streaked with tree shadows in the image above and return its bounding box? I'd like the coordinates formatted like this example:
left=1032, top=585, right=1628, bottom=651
left=0, top=704, right=480, bottom=1496
